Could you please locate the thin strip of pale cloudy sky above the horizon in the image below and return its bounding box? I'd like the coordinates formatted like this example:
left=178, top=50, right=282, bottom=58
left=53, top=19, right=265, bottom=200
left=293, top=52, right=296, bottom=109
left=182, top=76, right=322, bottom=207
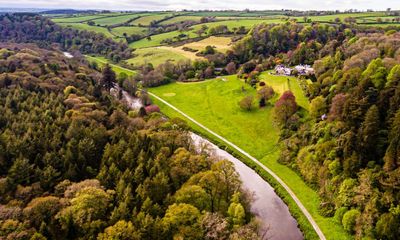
left=0, top=0, right=400, bottom=11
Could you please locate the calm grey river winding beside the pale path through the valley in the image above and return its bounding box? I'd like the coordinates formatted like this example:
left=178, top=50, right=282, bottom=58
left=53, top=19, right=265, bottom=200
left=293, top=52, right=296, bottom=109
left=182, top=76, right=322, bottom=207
left=114, top=86, right=303, bottom=240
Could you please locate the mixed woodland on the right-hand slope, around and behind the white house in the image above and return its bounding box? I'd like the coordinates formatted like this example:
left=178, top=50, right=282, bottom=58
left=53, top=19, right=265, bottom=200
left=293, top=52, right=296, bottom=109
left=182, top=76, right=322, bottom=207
left=233, top=24, right=400, bottom=239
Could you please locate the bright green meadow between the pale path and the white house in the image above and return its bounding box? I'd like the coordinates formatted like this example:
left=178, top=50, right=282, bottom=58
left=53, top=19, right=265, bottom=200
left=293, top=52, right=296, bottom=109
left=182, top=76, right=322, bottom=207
left=149, top=73, right=351, bottom=240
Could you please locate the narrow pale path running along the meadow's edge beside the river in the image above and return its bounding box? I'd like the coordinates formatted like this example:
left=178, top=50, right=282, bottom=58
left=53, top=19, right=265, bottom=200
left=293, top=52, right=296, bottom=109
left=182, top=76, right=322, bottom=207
left=148, top=92, right=326, bottom=240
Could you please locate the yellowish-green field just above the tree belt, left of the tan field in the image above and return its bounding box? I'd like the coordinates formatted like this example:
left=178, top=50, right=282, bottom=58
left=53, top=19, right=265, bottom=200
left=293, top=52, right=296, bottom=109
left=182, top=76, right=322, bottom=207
left=126, top=47, right=188, bottom=66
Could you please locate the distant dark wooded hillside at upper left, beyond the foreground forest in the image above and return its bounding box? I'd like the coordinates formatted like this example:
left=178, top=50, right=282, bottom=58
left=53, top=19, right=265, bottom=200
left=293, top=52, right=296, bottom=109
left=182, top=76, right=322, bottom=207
left=0, top=13, right=132, bottom=62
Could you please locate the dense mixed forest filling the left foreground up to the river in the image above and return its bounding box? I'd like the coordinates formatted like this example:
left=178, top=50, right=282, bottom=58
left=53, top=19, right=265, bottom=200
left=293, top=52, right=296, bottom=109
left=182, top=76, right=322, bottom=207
left=0, top=43, right=258, bottom=240
